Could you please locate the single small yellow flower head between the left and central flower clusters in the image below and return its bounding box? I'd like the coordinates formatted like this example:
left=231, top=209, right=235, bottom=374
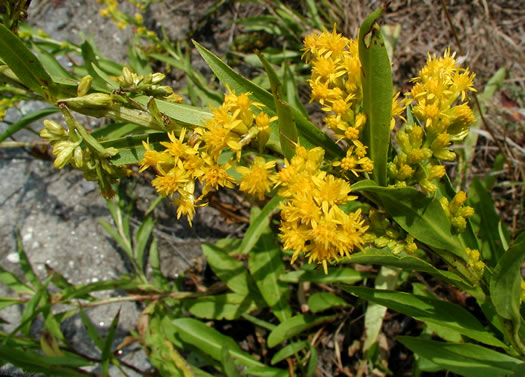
left=236, top=157, right=276, bottom=200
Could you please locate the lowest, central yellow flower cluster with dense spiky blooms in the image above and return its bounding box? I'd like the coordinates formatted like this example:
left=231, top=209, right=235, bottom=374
left=278, top=146, right=368, bottom=272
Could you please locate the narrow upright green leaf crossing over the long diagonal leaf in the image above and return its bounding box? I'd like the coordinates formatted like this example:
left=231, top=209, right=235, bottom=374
left=259, top=54, right=298, bottom=160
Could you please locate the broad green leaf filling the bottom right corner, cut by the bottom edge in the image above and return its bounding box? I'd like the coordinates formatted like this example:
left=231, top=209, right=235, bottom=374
left=398, top=336, right=523, bottom=377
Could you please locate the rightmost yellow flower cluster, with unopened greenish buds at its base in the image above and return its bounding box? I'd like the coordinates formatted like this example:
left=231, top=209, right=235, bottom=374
left=388, top=50, right=475, bottom=193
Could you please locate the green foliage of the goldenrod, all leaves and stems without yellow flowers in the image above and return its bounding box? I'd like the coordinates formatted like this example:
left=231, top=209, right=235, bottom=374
left=0, top=1, right=525, bottom=377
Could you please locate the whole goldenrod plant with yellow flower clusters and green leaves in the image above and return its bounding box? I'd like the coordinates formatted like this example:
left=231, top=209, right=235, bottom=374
left=0, top=1, right=525, bottom=377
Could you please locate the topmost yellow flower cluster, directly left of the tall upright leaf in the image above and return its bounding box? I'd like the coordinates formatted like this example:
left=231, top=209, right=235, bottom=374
left=303, top=26, right=403, bottom=176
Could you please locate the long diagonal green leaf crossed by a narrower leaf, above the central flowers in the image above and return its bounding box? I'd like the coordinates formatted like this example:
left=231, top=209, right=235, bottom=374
left=193, top=41, right=344, bottom=158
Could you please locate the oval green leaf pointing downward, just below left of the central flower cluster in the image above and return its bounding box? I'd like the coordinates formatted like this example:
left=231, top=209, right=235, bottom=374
left=248, top=228, right=292, bottom=322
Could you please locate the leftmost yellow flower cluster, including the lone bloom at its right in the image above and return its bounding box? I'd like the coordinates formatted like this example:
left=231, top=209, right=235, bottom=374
left=140, top=90, right=275, bottom=224
